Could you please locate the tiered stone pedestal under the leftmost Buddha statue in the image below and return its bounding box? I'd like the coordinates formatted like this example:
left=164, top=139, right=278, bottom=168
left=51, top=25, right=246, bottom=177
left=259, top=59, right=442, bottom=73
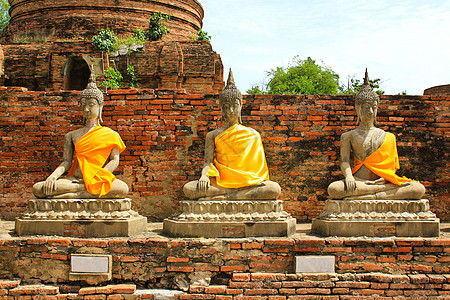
left=15, top=198, right=147, bottom=237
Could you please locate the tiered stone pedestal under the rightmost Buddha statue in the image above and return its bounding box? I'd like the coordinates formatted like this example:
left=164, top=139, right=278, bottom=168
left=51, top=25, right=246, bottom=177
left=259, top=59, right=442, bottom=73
left=311, top=199, right=439, bottom=237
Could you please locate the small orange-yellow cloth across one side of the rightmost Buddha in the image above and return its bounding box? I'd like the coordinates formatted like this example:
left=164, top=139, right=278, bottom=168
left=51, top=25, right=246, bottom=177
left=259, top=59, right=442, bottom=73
left=352, top=132, right=412, bottom=185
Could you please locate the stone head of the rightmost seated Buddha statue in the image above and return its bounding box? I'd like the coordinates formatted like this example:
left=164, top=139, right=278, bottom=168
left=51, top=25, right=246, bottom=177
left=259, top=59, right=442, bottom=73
left=355, top=69, right=380, bottom=125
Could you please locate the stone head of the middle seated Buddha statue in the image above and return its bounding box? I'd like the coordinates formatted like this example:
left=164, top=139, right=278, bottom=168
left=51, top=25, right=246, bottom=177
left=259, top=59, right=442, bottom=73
left=219, top=69, right=242, bottom=123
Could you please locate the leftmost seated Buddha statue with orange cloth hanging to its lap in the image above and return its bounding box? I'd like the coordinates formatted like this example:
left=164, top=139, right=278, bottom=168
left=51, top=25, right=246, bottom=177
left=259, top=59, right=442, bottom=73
left=33, top=71, right=128, bottom=199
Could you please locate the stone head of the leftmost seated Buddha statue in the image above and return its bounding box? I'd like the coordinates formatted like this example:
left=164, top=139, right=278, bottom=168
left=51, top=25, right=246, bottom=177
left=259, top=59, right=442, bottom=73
left=80, top=69, right=104, bottom=122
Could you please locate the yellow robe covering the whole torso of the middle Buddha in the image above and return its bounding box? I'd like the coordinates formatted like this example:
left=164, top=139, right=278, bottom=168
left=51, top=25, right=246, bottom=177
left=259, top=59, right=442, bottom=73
left=208, top=124, right=269, bottom=188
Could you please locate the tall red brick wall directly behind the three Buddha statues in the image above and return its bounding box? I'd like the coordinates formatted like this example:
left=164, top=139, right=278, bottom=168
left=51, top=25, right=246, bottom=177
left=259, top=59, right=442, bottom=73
left=0, top=88, right=450, bottom=222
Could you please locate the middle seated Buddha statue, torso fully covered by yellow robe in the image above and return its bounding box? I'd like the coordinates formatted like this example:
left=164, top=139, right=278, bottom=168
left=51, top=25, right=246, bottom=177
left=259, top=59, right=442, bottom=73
left=183, top=70, right=281, bottom=200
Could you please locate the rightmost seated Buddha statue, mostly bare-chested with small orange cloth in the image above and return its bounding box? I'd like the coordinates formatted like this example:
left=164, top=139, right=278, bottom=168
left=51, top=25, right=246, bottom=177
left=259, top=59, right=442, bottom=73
left=328, top=70, right=425, bottom=200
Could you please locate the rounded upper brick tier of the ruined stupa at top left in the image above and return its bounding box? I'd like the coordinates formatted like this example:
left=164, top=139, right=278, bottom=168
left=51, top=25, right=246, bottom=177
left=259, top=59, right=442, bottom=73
left=2, top=0, right=204, bottom=43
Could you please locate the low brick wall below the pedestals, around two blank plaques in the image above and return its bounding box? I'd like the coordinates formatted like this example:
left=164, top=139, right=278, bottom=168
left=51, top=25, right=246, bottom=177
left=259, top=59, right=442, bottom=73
left=0, top=237, right=450, bottom=299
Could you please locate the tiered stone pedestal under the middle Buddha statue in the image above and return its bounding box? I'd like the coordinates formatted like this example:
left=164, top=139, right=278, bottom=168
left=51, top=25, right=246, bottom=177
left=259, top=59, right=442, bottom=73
left=163, top=200, right=296, bottom=238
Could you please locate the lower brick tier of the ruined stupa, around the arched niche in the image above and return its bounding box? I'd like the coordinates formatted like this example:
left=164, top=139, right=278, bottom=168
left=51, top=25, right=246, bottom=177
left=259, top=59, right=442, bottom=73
left=0, top=41, right=224, bottom=94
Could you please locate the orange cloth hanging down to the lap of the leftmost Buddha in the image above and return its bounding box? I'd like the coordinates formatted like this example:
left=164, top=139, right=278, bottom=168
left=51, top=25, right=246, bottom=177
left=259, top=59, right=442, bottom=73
left=69, top=125, right=125, bottom=196
